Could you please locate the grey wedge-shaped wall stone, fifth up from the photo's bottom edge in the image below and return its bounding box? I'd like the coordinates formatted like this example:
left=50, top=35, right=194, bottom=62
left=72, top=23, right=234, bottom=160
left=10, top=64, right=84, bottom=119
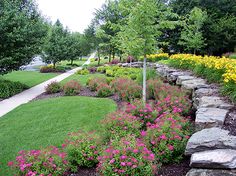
left=198, top=96, right=233, bottom=109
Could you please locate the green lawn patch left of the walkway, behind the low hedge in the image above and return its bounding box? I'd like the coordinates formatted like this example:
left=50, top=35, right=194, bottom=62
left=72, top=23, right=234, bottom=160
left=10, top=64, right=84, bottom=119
left=0, top=71, right=58, bottom=87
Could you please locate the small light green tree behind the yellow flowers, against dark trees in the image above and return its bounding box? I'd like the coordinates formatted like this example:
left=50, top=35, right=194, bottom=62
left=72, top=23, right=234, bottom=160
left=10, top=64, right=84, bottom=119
left=179, top=7, right=207, bottom=54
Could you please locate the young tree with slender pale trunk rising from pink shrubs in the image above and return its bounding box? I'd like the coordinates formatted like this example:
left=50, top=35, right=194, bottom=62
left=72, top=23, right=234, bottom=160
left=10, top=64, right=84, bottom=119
left=119, top=0, right=158, bottom=103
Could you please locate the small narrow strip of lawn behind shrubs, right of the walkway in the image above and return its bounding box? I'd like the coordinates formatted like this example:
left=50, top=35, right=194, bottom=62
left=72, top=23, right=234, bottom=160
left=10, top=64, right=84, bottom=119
left=61, top=73, right=105, bottom=86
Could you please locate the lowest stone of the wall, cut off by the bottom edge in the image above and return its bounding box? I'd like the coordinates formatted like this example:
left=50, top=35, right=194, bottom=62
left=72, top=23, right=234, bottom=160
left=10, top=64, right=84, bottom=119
left=186, top=169, right=236, bottom=176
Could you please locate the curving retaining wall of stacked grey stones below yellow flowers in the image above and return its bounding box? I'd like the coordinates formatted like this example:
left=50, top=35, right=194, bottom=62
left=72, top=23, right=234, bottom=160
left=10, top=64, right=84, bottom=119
left=123, top=63, right=236, bottom=176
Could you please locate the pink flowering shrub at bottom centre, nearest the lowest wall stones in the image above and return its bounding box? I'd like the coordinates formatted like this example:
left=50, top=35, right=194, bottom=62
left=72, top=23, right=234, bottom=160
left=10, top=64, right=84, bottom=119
left=97, top=135, right=157, bottom=176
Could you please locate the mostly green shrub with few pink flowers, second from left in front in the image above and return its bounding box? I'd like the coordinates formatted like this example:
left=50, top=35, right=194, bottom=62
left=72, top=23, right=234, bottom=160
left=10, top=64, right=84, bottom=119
left=62, top=131, right=100, bottom=171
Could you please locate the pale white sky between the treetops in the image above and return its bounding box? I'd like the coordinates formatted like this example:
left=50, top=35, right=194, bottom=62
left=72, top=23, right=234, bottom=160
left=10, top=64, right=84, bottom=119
left=36, top=0, right=105, bottom=33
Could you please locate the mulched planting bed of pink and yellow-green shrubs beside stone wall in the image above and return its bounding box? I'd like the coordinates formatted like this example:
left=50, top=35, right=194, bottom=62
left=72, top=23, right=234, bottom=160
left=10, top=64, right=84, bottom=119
left=6, top=66, right=196, bottom=176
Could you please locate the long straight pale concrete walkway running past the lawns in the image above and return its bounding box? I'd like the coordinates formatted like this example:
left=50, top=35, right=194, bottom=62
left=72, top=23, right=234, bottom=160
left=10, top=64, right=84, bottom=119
left=0, top=53, right=95, bottom=117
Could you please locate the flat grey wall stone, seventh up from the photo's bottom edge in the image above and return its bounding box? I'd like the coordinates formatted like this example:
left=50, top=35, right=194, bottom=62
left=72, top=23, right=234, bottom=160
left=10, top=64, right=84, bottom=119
left=181, top=78, right=210, bottom=90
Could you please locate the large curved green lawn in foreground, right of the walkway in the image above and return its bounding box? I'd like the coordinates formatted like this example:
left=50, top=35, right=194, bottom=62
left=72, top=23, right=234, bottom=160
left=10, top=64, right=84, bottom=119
left=0, top=96, right=116, bottom=176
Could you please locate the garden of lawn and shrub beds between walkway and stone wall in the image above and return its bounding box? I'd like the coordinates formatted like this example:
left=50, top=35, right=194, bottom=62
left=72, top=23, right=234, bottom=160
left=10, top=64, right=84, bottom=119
left=1, top=61, right=192, bottom=175
